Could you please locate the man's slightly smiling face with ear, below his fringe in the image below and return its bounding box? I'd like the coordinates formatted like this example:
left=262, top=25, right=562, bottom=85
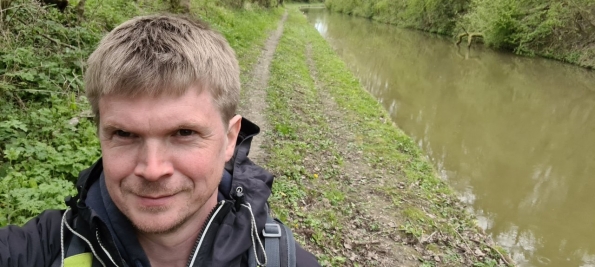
left=99, top=87, right=241, bottom=233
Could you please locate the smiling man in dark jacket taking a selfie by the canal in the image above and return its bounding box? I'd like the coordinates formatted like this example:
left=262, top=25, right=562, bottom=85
left=0, top=16, right=319, bottom=267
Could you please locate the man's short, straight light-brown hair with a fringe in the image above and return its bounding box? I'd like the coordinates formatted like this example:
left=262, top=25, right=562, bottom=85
left=85, top=15, right=241, bottom=122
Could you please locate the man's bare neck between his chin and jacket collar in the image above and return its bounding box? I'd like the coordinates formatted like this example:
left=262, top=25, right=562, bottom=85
left=137, top=194, right=217, bottom=267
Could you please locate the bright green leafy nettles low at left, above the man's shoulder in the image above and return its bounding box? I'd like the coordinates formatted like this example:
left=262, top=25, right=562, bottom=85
left=0, top=95, right=99, bottom=225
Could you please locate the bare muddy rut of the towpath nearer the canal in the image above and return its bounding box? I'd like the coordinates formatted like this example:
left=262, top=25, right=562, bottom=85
left=305, top=44, right=419, bottom=266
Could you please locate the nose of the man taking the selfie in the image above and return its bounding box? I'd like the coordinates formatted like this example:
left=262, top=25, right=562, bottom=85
left=134, top=140, right=174, bottom=181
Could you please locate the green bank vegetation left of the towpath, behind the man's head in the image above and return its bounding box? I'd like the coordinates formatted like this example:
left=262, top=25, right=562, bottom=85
left=0, top=0, right=281, bottom=226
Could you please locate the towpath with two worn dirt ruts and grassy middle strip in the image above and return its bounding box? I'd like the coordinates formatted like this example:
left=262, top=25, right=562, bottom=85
left=240, top=8, right=506, bottom=266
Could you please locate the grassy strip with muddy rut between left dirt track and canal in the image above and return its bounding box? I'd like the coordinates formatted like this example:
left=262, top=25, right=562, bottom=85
left=266, top=6, right=510, bottom=266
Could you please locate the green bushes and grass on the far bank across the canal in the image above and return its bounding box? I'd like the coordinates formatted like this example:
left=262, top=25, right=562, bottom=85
left=325, top=0, right=595, bottom=68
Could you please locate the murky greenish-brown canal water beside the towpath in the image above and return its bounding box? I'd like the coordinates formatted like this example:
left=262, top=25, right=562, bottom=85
left=306, top=9, right=595, bottom=267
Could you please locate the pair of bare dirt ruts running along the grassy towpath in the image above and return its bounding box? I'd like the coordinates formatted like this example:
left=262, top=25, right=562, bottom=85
left=240, top=12, right=417, bottom=266
